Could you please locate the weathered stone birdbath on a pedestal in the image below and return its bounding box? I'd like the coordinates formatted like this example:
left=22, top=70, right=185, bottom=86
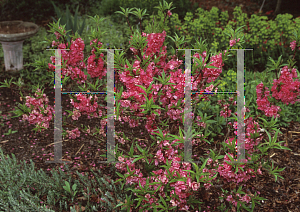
left=0, top=21, right=39, bottom=73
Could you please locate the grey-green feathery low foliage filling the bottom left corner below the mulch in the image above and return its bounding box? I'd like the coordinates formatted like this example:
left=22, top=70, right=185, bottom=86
left=0, top=149, right=135, bottom=212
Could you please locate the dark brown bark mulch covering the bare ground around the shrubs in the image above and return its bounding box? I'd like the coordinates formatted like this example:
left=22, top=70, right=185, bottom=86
left=0, top=66, right=300, bottom=212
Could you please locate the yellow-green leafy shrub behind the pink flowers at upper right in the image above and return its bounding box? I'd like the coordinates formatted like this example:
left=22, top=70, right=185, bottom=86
left=164, top=7, right=300, bottom=71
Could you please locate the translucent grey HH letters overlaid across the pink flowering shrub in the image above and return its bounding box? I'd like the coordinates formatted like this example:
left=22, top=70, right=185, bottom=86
left=46, top=49, right=253, bottom=166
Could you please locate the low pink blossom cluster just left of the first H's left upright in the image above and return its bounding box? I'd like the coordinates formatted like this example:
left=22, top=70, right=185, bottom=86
left=22, top=89, right=55, bottom=130
